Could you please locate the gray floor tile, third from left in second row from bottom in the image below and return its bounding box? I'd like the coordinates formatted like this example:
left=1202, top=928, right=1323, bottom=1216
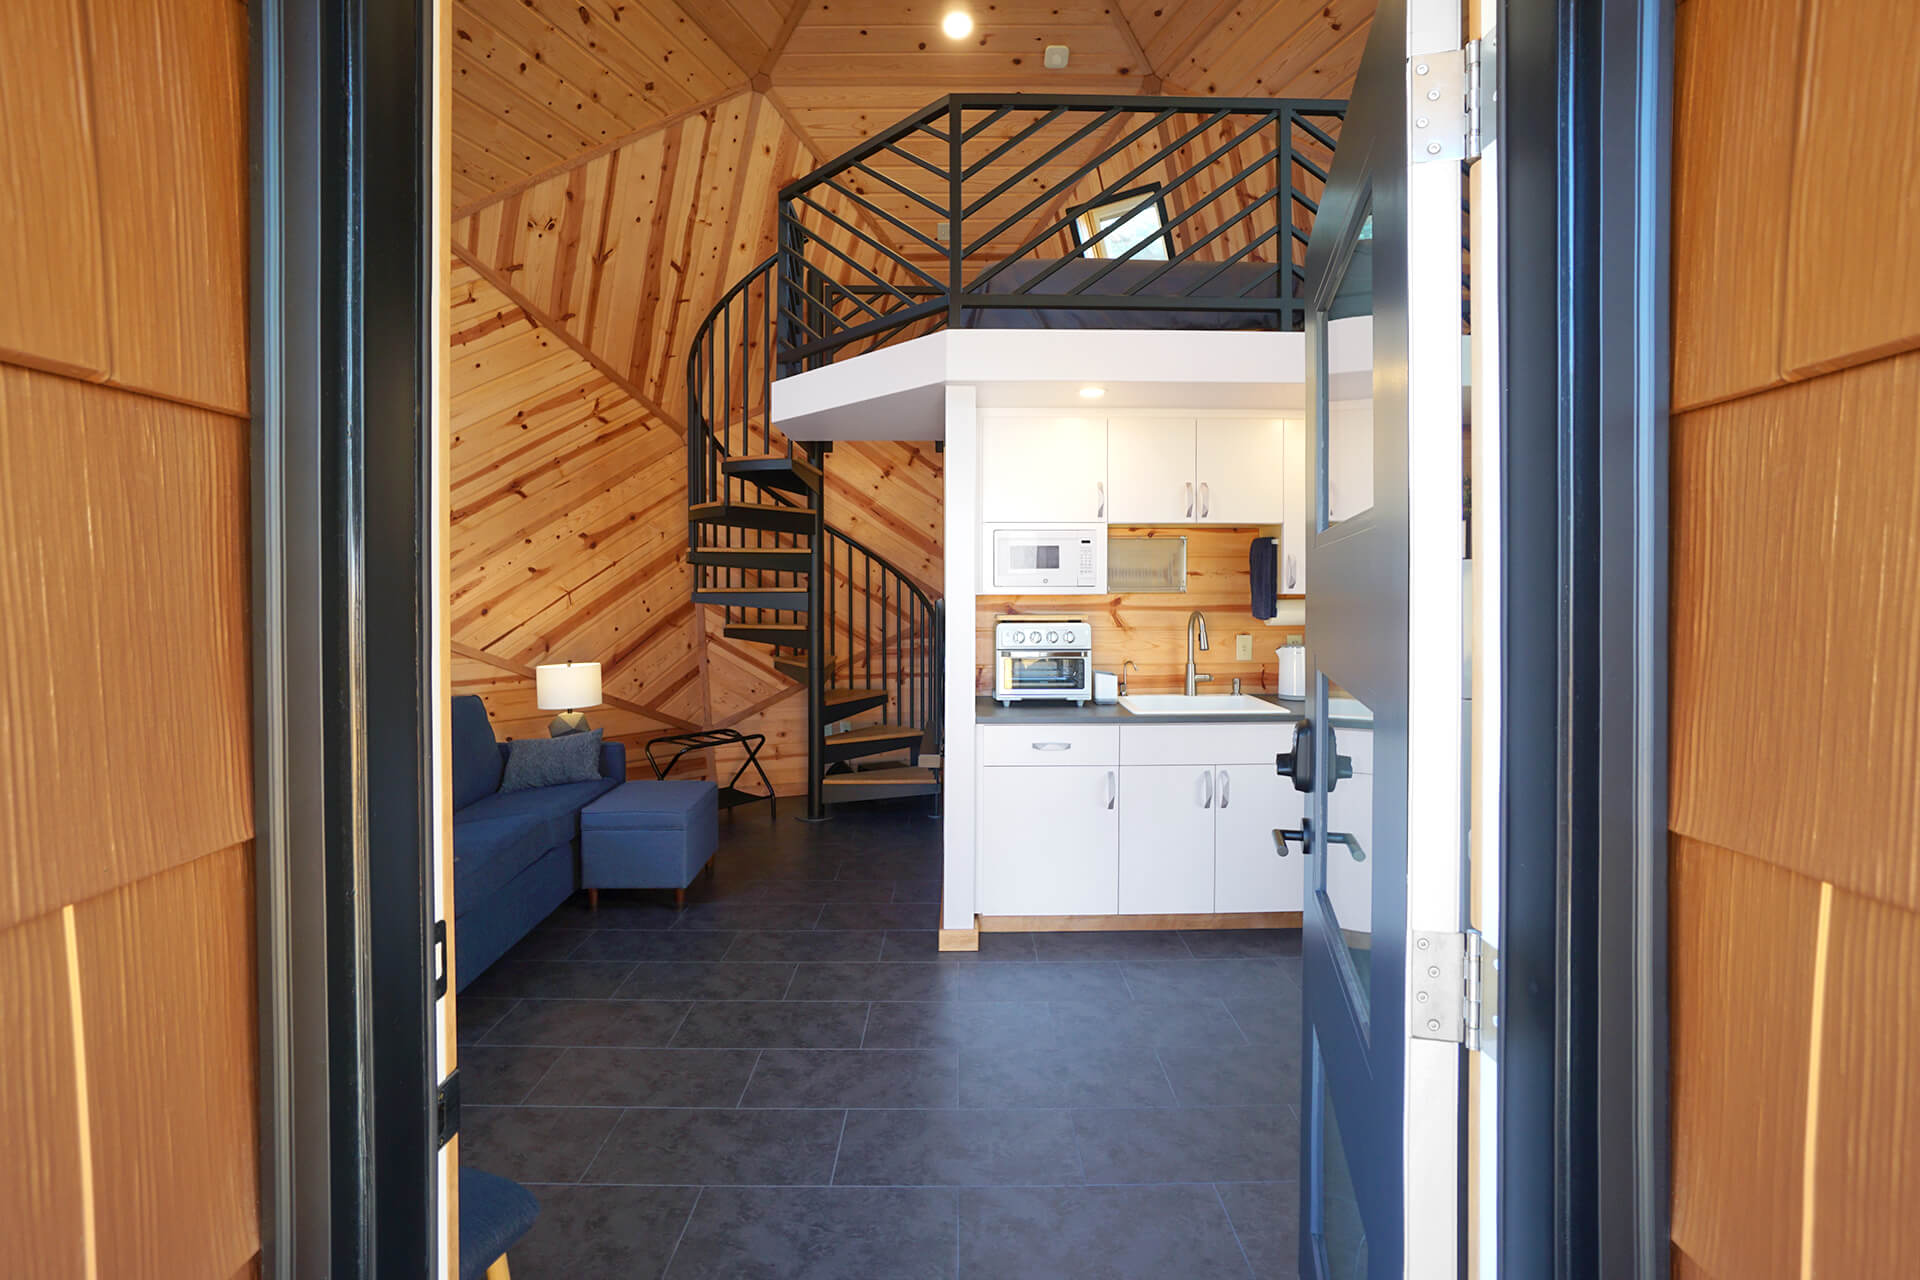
left=833, top=1111, right=1081, bottom=1186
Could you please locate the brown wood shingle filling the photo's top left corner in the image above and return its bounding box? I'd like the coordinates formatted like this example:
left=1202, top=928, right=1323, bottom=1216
left=0, top=0, right=109, bottom=376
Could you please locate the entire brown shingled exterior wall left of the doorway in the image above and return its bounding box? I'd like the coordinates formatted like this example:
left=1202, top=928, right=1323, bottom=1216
left=0, top=0, right=259, bottom=1280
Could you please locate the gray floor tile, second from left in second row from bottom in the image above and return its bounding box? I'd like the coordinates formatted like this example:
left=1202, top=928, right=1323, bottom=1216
left=584, top=1107, right=845, bottom=1186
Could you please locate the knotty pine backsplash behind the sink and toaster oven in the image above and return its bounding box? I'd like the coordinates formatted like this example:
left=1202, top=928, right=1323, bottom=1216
left=973, top=526, right=1302, bottom=693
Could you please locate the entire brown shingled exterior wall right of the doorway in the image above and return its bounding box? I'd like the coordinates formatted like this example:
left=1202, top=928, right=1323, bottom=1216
left=1670, top=0, right=1920, bottom=1280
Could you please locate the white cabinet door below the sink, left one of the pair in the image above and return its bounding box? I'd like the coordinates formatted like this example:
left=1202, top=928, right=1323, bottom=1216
left=1119, top=764, right=1215, bottom=915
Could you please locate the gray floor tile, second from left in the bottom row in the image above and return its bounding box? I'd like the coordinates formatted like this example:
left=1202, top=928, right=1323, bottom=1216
left=664, top=1186, right=954, bottom=1280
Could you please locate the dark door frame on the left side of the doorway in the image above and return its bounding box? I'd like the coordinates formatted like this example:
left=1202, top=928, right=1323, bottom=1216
left=248, top=0, right=440, bottom=1280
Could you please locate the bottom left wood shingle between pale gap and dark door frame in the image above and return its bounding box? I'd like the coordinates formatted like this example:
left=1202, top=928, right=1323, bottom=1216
left=75, top=844, right=259, bottom=1276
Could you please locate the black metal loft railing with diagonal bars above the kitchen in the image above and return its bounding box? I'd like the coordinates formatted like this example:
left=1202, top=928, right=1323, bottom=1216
left=778, top=94, right=1346, bottom=368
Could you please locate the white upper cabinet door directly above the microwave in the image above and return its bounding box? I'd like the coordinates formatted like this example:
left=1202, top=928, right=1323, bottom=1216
left=979, top=413, right=1108, bottom=524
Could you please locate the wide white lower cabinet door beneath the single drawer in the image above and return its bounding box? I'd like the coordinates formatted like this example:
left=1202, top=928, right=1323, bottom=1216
left=979, top=766, right=1119, bottom=915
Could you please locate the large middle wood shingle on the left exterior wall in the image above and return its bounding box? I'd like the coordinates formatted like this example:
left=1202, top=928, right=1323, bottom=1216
left=0, top=367, right=252, bottom=923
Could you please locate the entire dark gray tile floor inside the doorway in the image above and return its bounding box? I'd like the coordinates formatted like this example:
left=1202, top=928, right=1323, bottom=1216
left=459, top=800, right=1300, bottom=1280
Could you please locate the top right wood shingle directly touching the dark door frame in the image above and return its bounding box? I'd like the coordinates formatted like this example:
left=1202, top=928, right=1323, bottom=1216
left=1672, top=0, right=1809, bottom=409
